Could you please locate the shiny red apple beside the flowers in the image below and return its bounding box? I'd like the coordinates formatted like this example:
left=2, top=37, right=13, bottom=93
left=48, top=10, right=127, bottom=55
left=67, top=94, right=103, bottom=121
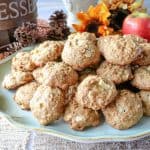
left=122, top=12, right=150, bottom=41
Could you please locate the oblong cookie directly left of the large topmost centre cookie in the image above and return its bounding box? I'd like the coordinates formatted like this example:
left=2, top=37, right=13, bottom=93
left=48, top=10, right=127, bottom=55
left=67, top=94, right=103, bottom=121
left=31, top=41, right=64, bottom=67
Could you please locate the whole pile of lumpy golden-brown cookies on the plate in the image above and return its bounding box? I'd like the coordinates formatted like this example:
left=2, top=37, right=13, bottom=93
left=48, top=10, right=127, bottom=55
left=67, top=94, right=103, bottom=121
left=3, top=32, right=150, bottom=130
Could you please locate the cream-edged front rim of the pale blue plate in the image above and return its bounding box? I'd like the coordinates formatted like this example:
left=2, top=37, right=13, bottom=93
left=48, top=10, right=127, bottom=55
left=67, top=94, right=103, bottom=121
left=0, top=111, right=150, bottom=143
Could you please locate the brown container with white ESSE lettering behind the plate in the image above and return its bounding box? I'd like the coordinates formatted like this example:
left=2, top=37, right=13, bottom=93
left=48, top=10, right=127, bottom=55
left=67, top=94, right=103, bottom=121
left=0, top=0, right=37, bottom=46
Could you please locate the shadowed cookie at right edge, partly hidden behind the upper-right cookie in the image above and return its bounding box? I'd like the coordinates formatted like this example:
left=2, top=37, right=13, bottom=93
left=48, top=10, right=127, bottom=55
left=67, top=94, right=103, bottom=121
left=133, top=43, right=150, bottom=66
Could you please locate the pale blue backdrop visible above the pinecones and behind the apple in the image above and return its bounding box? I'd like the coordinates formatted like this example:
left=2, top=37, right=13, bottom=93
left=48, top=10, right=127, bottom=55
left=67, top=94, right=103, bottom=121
left=38, top=0, right=150, bottom=19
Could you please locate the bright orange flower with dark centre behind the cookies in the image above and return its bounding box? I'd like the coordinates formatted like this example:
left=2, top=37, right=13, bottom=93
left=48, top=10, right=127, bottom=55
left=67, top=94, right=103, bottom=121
left=73, top=3, right=113, bottom=36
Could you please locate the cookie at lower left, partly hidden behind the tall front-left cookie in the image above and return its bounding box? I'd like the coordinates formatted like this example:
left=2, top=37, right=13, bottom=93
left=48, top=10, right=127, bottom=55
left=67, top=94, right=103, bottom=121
left=14, top=82, right=38, bottom=110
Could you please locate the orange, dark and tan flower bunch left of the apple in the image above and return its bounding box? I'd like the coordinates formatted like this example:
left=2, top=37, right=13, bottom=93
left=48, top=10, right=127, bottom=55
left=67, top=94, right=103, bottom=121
left=73, top=0, right=144, bottom=37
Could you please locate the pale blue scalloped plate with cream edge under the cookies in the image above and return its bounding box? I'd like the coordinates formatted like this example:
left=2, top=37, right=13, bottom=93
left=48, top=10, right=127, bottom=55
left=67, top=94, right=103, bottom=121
left=0, top=48, right=150, bottom=143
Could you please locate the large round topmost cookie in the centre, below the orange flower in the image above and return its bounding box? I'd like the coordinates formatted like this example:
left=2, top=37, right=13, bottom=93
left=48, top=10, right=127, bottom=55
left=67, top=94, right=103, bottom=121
left=62, top=32, right=100, bottom=71
